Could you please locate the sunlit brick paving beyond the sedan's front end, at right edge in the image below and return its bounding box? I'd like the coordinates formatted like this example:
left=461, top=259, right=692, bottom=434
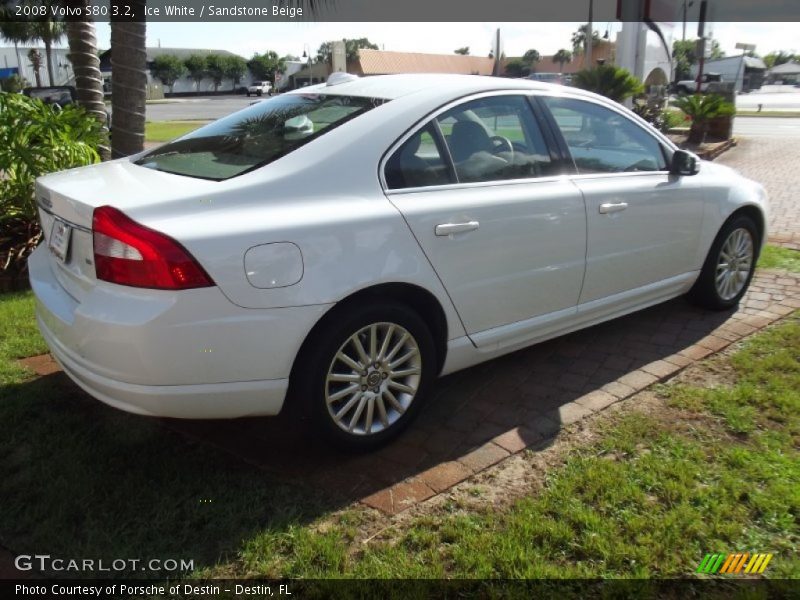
left=716, top=136, right=800, bottom=250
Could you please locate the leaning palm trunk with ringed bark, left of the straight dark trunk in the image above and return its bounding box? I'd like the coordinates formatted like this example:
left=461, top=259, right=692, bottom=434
left=66, top=7, right=111, bottom=160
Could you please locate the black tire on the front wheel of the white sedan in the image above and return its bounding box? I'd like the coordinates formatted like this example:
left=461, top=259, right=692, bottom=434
left=688, top=215, right=761, bottom=310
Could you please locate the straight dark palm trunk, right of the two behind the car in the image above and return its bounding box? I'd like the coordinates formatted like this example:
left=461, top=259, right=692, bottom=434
left=111, top=7, right=147, bottom=158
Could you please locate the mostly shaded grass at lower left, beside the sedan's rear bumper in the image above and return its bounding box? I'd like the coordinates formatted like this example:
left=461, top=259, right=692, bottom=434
left=0, top=292, right=329, bottom=576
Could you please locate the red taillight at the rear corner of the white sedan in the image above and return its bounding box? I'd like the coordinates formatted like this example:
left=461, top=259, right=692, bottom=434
left=92, top=206, right=214, bottom=290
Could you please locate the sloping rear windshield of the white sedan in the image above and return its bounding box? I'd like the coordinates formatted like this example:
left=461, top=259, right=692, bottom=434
left=136, top=94, right=386, bottom=181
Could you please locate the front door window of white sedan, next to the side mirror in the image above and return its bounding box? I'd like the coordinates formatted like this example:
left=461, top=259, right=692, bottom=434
left=542, top=97, right=667, bottom=173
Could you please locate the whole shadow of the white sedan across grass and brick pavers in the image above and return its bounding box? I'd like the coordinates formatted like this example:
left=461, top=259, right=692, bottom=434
left=0, top=299, right=731, bottom=576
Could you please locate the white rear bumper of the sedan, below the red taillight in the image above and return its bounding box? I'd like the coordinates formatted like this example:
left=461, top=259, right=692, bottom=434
left=28, top=247, right=328, bottom=419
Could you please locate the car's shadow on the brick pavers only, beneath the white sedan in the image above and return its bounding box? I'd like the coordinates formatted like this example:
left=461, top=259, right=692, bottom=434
left=159, top=299, right=731, bottom=503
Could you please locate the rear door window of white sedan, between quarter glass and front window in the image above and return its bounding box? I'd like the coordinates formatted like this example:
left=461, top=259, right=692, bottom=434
left=436, top=96, right=554, bottom=183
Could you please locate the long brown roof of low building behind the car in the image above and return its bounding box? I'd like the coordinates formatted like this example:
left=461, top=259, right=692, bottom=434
left=358, top=48, right=494, bottom=75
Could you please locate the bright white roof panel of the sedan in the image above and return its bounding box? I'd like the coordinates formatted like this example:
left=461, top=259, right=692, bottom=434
left=289, top=73, right=577, bottom=100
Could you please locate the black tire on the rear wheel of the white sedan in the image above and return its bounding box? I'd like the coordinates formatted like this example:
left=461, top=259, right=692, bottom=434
left=292, top=301, right=437, bottom=451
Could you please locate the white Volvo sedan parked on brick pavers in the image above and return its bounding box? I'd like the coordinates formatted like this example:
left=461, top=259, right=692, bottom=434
left=29, top=75, right=767, bottom=448
